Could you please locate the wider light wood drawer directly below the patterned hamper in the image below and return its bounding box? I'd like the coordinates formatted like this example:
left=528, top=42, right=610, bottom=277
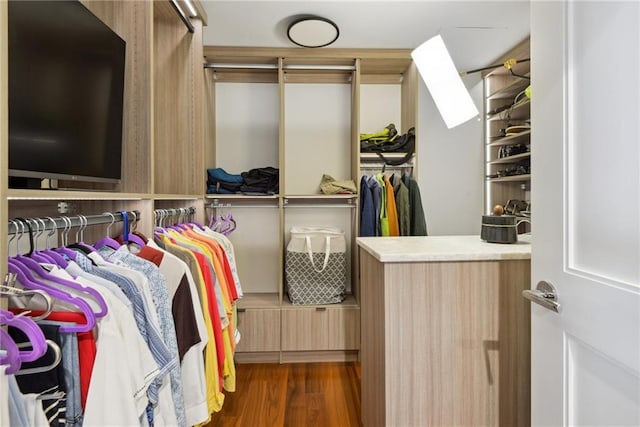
left=282, top=306, right=360, bottom=351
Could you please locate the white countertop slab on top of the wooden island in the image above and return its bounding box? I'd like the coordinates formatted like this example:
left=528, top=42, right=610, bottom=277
left=356, top=234, right=531, bottom=262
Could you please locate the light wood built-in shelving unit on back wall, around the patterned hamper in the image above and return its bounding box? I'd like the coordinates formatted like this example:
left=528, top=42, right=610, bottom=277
left=204, top=46, right=417, bottom=362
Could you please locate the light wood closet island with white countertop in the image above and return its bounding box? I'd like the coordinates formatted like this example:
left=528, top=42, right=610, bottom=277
left=357, top=235, right=531, bottom=427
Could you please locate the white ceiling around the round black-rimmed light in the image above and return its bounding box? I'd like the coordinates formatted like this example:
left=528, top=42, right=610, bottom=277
left=201, top=0, right=529, bottom=71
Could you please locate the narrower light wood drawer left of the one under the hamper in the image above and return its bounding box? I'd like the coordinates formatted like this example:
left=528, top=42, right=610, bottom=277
left=236, top=308, right=280, bottom=353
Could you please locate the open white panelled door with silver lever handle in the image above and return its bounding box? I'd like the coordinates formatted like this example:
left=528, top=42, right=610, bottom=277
left=531, top=0, right=640, bottom=426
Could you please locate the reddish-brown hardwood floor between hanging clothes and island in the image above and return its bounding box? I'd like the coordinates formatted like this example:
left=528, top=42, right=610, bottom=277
left=207, top=362, right=362, bottom=427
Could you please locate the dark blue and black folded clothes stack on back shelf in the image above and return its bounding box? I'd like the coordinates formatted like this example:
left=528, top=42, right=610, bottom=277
left=207, top=166, right=280, bottom=195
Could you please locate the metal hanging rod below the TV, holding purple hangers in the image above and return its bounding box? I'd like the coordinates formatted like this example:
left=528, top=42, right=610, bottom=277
left=8, top=210, right=140, bottom=234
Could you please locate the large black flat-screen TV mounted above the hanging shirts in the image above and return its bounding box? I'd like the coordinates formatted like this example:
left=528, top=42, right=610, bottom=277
left=8, top=0, right=126, bottom=186
